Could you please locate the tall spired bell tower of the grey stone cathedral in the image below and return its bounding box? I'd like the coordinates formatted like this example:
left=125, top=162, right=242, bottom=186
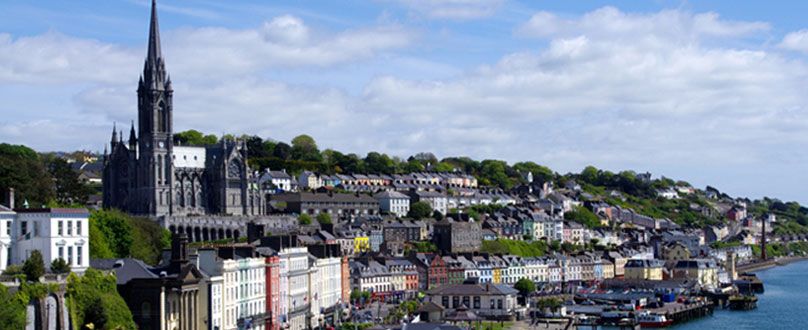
left=135, top=0, right=174, bottom=216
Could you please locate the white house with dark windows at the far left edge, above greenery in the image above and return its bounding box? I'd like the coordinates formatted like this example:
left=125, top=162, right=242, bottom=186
left=0, top=207, right=90, bottom=272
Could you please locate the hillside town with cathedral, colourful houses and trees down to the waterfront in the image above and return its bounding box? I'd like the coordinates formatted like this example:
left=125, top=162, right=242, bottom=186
left=0, top=2, right=808, bottom=330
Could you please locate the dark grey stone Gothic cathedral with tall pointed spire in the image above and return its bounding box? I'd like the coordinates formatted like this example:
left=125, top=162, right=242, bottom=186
left=103, top=1, right=263, bottom=218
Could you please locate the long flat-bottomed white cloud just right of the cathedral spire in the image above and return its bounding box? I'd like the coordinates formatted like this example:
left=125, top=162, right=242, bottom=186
left=163, top=15, right=415, bottom=77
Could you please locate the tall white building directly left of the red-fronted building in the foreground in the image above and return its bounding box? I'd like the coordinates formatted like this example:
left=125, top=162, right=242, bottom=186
left=198, top=248, right=266, bottom=330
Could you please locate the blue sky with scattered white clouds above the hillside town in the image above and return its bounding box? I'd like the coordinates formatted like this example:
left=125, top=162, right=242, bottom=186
left=0, top=0, right=808, bottom=204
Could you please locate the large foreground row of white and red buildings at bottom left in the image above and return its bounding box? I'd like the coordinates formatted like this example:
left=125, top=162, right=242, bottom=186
left=92, top=233, right=350, bottom=330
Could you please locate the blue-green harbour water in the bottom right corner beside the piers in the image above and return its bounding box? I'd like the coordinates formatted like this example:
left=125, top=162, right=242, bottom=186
left=672, top=261, right=808, bottom=330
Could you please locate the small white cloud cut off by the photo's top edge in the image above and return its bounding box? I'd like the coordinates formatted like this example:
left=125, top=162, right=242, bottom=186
left=386, top=0, right=505, bottom=20
